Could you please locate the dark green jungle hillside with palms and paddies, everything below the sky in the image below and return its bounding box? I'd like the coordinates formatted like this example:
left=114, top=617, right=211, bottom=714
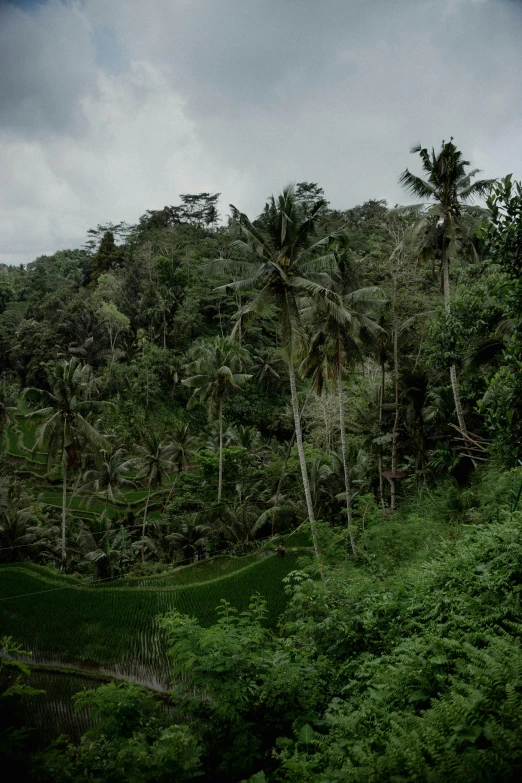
left=0, top=141, right=522, bottom=783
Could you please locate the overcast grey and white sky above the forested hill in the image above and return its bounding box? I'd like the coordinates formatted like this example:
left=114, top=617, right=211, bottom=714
left=0, top=0, right=522, bottom=263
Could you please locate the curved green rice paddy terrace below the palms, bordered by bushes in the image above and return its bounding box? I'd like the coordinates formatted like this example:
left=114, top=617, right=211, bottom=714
left=0, top=549, right=308, bottom=688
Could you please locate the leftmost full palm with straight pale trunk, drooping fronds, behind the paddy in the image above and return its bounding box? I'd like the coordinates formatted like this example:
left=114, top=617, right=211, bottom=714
left=23, top=357, right=111, bottom=568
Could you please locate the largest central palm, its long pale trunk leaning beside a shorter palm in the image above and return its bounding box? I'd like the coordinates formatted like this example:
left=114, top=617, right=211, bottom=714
left=216, top=185, right=334, bottom=558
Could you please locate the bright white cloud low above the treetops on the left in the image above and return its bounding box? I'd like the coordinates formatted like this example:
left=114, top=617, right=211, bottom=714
left=0, top=0, right=241, bottom=263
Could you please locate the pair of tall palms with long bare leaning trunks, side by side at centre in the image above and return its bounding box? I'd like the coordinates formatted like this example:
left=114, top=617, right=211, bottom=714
left=208, top=186, right=383, bottom=558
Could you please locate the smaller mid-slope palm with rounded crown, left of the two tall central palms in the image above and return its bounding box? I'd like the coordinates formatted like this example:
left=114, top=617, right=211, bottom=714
left=182, top=337, right=252, bottom=501
